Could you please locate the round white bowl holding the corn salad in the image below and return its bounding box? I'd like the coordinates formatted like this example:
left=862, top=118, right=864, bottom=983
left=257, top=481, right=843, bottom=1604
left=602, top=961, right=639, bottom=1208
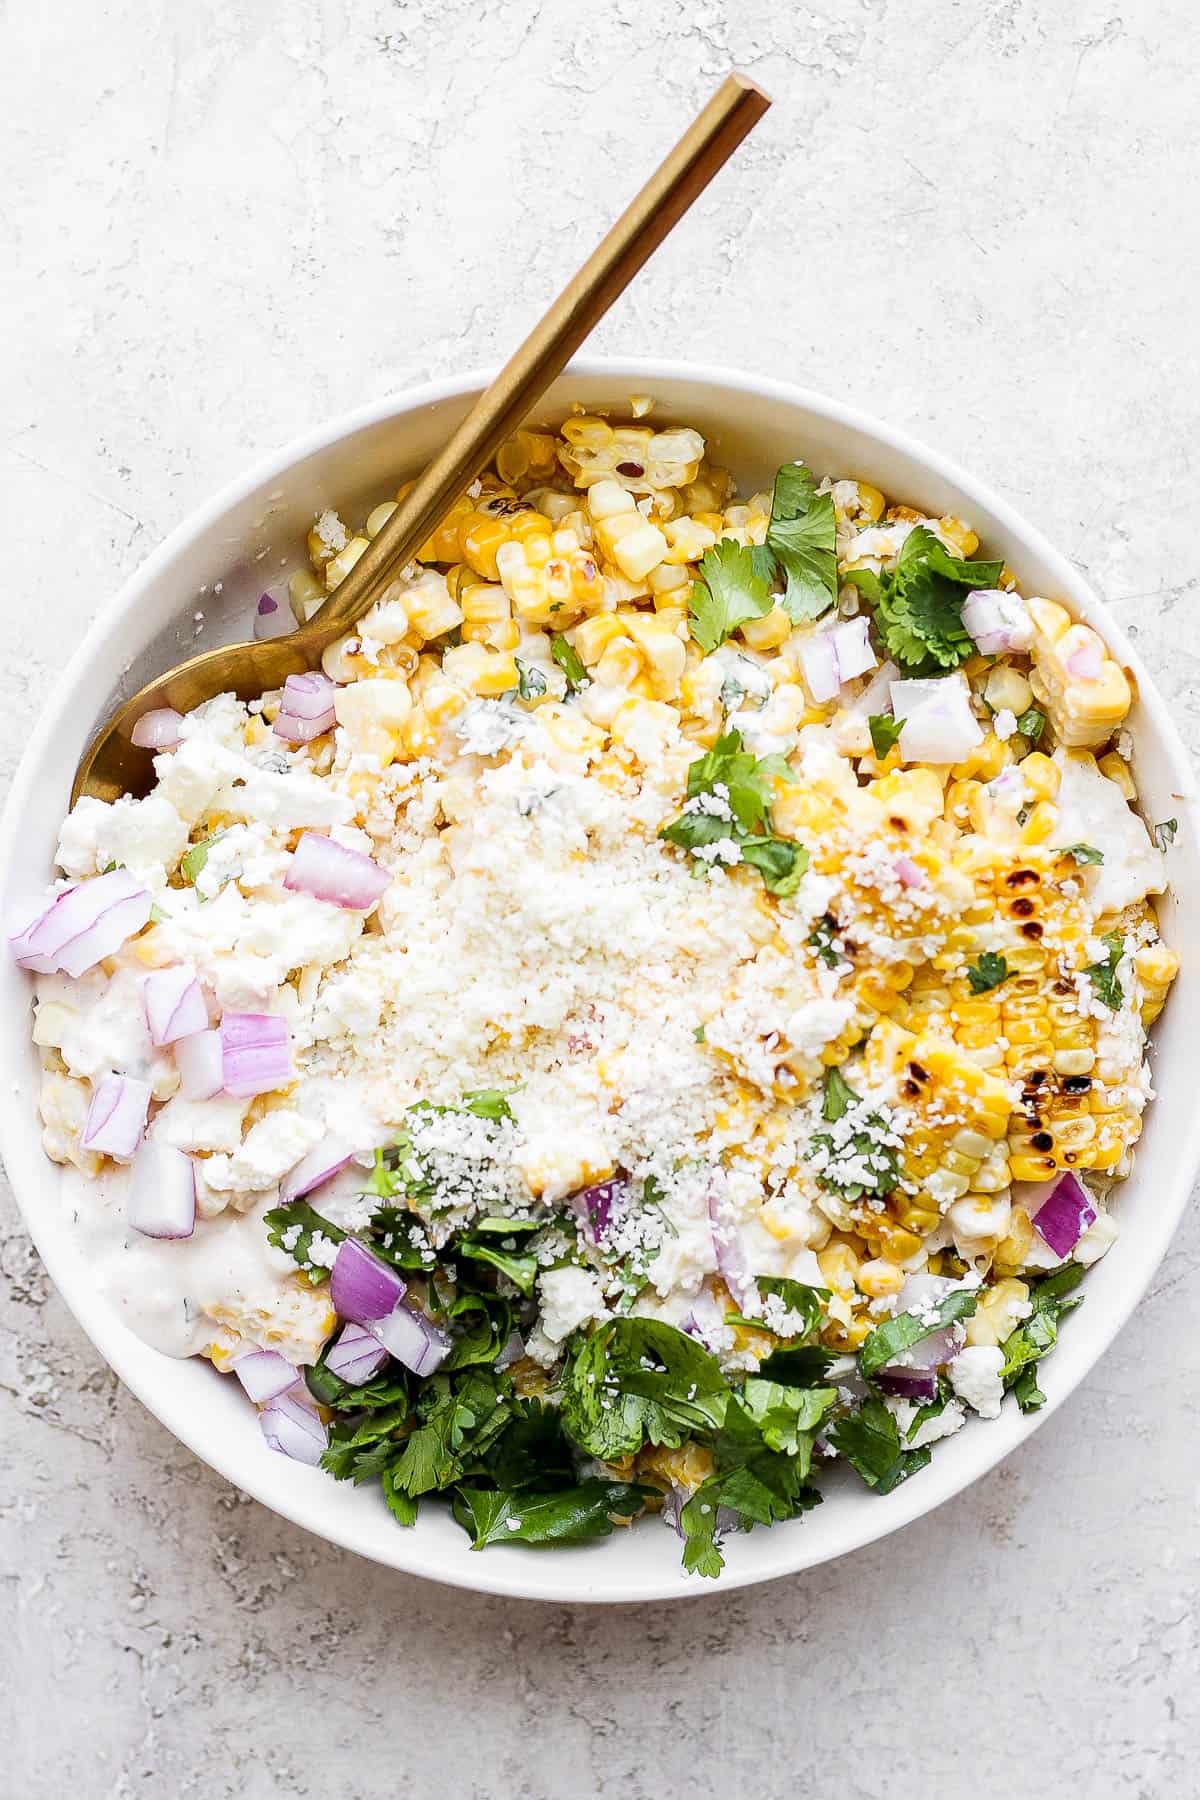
left=0, top=360, right=1200, bottom=1600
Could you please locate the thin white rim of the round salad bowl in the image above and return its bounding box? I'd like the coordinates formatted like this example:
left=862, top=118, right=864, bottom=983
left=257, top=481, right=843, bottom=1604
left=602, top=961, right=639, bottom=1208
left=0, top=355, right=1200, bottom=1604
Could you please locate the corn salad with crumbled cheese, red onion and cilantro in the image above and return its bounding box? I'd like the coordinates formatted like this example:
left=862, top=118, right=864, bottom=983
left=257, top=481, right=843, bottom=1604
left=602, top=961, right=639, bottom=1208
left=13, top=400, right=1177, bottom=1575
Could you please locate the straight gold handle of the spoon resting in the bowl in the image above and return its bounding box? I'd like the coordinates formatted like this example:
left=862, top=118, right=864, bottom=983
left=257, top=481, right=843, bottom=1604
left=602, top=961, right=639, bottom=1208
left=306, top=74, right=770, bottom=641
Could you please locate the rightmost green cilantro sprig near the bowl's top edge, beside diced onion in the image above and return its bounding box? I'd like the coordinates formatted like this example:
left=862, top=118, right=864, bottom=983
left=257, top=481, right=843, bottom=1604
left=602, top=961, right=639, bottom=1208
left=846, top=526, right=1002, bottom=675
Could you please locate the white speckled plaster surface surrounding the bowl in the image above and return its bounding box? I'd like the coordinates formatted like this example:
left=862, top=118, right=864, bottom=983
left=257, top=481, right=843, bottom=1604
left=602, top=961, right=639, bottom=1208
left=0, top=0, right=1200, bottom=1800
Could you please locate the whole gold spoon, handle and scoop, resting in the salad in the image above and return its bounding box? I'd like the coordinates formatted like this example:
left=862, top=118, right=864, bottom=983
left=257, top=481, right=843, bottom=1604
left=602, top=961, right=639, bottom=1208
left=70, top=74, right=770, bottom=805
